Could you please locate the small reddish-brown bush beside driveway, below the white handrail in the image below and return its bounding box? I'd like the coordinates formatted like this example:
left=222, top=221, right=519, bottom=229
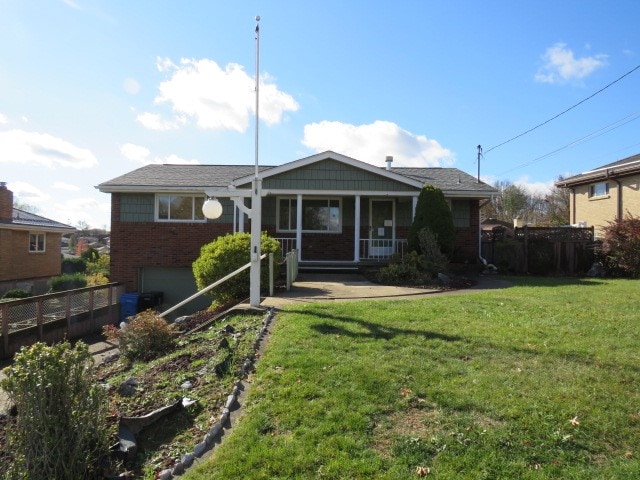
left=103, top=310, right=177, bottom=361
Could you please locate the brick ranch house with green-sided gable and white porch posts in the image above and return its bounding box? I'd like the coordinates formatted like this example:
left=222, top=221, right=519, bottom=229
left=96, top=151, right=497, bottom=303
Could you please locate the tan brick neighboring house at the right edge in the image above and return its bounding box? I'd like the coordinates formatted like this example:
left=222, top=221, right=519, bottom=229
left=556, top=154, right=640, bottom=237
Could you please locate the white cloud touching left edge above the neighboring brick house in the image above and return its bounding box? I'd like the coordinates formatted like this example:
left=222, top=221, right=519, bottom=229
left=0, top=130, right=98, bottom=168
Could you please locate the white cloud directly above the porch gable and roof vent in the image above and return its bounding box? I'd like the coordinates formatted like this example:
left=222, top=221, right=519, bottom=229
left=302, top=120, right=455, bottom=167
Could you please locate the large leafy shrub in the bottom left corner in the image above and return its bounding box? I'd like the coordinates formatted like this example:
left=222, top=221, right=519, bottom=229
left=0, top=342, right=109, bottom=480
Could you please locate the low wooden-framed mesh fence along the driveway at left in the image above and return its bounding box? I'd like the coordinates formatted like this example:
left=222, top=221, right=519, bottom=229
left=0, top=283, right=125, bottom=358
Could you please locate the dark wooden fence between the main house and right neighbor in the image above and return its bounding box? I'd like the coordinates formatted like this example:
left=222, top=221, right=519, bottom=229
left=482, top=227, right=594, bottom=275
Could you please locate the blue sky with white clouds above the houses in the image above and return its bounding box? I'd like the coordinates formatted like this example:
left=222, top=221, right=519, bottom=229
left=0, top=0, right=640, bottom=228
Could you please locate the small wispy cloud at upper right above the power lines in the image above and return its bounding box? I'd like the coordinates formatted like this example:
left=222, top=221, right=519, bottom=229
left=534, top=43, right=607, bottom=83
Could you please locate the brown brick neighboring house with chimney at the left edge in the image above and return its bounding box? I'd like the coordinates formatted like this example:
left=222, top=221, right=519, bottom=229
left=0, top=182, right=76, bottom=297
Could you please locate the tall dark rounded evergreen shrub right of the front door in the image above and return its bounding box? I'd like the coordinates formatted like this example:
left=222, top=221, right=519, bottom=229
left=407, top=185, right=456, bottom=257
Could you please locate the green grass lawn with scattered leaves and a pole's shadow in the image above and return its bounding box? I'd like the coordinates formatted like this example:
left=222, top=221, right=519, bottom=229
left=184, top=278, right=640, bottom=480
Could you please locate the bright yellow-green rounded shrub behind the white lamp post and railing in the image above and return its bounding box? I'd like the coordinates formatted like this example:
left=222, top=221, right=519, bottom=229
left=193, top=232, right=282, bottom=303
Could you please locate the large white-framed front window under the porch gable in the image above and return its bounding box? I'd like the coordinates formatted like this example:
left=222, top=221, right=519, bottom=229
left=277, top=198, right=342, bottom=232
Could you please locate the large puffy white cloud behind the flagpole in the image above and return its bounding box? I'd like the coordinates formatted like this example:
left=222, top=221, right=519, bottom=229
left=138, top=58, right=299, bottom=132
